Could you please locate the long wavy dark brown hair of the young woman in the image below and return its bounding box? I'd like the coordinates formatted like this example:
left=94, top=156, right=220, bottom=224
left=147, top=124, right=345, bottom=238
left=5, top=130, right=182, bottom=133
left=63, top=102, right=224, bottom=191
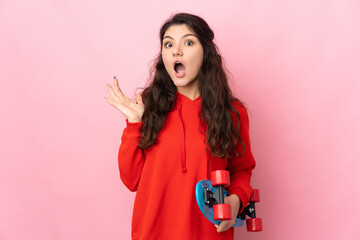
left=139, top=13, right=245, bottom=158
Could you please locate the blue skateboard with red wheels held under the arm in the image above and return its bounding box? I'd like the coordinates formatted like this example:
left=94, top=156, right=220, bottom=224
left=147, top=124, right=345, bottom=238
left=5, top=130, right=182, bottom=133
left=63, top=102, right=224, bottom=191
left=195, top=170, right=262, bottom=232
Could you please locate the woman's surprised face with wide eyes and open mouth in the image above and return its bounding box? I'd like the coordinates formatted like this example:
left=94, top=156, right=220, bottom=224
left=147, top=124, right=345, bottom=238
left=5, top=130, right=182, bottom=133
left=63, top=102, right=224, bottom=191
left=161, top=24, right=204, bottom=96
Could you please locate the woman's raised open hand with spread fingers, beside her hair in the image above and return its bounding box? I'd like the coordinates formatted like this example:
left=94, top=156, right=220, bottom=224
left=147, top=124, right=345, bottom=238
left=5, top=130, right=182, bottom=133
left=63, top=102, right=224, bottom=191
left=105, top=77, right=144, bottom=122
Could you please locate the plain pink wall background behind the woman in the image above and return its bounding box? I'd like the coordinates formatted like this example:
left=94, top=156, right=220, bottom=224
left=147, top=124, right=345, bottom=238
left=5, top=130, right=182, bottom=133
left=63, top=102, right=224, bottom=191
left=0, top=0, right=360, bottom=240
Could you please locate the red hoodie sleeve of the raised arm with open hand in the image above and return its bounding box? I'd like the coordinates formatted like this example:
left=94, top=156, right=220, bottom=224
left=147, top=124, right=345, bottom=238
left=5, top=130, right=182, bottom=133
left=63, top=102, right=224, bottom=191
left=118, top=120, right=145, bottom=192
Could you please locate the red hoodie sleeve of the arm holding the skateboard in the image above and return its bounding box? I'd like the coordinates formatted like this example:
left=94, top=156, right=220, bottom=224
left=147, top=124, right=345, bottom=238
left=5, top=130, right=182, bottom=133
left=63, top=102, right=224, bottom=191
left=228, top=103, right=256, bottom=212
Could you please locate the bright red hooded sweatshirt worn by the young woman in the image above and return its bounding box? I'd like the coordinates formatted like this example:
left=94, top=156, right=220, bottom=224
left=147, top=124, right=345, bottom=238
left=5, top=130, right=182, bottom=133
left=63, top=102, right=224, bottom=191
left=118, top=93, right=255, bottom=240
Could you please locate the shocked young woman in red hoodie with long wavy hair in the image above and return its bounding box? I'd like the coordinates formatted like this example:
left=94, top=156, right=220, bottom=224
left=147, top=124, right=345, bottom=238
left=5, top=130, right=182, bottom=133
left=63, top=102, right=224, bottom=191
left=106, top=13, right=255, bottom=240
